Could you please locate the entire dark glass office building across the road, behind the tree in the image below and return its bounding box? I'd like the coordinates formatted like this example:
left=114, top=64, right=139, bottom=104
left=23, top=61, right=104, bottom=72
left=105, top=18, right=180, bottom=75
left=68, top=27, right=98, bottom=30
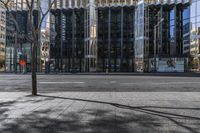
left=1, top=0, right=200, bottom=72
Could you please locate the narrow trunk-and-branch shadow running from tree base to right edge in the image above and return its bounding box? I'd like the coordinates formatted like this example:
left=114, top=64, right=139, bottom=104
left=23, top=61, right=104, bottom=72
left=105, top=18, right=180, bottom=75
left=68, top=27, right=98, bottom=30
left=38, top=95, right=200, bottom=133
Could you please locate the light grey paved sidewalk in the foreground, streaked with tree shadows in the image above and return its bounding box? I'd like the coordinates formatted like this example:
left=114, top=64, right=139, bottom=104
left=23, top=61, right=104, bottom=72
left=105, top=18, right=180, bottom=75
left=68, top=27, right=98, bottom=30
left=0, top=92, right=200, bottom=133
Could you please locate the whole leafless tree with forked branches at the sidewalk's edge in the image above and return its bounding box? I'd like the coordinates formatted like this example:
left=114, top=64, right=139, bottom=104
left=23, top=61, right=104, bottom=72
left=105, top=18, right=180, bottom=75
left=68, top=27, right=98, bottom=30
left=0, top=0, right=55, bottom=95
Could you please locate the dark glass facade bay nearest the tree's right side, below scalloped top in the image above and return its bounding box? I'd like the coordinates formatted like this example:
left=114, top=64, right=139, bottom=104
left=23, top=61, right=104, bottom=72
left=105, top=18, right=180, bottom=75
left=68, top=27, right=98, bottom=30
left=50, top=8, right=84, bottom=72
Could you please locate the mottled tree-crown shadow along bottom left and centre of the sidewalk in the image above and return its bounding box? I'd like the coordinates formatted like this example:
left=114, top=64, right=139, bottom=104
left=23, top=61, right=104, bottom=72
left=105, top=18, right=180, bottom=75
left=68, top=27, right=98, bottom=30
left=0, top=109, right=164, bottom=133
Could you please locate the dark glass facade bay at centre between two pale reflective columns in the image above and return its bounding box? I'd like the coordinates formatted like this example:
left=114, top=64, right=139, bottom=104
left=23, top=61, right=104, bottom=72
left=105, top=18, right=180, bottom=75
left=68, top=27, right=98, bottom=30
left=97, top=7, right=134, bottom=72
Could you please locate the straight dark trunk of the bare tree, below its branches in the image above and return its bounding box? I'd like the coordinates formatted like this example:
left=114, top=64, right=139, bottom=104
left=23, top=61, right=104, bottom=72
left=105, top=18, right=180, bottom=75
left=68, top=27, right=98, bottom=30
left=31, top=41, right=37, bottom=95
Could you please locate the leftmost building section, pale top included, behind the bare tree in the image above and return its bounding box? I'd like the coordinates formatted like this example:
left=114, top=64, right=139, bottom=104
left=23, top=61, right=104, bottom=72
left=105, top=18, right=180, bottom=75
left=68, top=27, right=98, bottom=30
left=4, top=0, right=40, bottom=73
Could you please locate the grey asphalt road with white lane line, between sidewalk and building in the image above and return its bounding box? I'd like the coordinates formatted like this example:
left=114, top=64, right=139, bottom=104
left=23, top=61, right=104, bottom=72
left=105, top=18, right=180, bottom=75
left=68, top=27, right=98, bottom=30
left=0, top=74, right=200, bottom=92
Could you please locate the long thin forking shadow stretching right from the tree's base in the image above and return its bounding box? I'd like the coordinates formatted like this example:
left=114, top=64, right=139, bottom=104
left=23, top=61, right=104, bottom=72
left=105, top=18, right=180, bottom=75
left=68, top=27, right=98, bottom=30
left=39, top=95, right=200, bottom=133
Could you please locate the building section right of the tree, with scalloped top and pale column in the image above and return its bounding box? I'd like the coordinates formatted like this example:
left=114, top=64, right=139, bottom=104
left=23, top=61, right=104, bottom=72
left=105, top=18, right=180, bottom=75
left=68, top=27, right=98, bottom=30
left=49, top=0, right=97, bottom=72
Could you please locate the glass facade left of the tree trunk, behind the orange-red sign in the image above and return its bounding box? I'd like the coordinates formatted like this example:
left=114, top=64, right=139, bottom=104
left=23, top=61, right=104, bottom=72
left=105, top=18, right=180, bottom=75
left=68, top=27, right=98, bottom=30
left=5, top=11, right=31, bottom=72
